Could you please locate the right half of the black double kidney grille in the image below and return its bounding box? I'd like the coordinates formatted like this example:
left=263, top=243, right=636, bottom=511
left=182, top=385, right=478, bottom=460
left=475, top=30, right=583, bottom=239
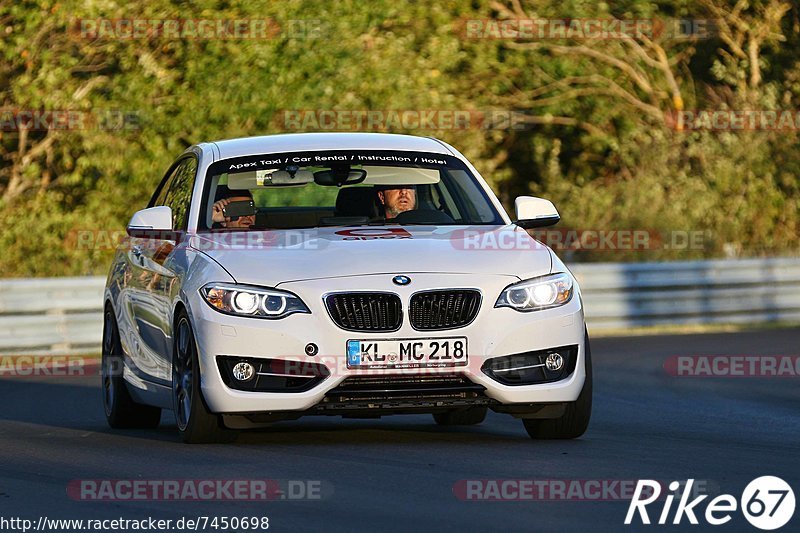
left=408, top=289, right=481, bottom=331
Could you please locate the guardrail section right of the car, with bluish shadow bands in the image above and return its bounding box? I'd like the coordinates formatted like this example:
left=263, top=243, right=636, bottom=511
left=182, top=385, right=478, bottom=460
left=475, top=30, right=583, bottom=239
left=571, top=259, right=800, bottom=329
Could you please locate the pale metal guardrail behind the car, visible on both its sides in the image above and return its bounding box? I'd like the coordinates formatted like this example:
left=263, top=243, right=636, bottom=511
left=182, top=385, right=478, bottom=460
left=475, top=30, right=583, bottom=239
left=0, top=258, right=800, bottom=354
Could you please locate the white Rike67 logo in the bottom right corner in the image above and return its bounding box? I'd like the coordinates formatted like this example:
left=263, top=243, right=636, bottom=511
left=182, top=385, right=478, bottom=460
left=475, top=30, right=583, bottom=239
left=625, top=476, right=795, bottom=531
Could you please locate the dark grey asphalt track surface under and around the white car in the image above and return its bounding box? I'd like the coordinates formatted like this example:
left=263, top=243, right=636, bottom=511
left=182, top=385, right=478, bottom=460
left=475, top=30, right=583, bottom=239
left=0, top=329, right=800, bottom=531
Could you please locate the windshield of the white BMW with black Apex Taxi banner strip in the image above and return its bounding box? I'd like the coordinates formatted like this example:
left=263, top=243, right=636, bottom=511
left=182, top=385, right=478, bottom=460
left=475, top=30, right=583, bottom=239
left=198, top=151, right=503, bottom=230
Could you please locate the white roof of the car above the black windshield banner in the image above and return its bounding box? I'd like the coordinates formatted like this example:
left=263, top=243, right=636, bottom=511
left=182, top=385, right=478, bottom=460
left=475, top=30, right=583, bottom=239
left=200, top=132, right=456, bottom=159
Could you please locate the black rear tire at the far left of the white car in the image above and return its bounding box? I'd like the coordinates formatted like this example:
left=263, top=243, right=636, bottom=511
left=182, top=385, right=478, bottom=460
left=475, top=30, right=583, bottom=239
left=100, top=305, right=161, bottom=429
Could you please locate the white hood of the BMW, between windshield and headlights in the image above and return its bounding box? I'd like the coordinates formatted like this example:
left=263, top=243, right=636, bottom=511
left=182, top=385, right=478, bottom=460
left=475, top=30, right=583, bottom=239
left=188, top=225, right=552, bottom=287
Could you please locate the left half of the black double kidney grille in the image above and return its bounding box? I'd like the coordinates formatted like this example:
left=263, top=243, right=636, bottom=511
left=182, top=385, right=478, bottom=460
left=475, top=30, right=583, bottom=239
left=325, top=292, right=403, bottom=331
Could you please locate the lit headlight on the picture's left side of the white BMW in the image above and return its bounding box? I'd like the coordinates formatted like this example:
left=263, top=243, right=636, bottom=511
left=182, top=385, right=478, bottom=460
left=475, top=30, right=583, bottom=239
left=200, top=283, right=311, bottom=319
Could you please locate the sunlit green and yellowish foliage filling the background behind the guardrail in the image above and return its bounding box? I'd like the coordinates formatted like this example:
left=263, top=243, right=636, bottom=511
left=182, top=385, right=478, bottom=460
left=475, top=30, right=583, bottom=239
left=0, top=0, right=800, bottom=277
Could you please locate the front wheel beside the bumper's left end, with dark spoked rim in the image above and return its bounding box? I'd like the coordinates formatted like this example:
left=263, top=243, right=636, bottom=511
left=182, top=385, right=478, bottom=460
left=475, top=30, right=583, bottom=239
left=172, top=312, right=237, bottom=444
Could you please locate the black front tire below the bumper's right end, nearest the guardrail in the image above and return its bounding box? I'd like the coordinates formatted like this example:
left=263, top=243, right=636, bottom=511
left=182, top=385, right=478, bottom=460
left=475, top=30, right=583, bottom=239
left=522, top=332, right=592, bottom=439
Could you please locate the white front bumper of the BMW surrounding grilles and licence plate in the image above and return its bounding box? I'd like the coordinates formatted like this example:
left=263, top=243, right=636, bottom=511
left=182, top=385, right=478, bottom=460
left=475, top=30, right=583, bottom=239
left=189, top=274, right=586, bottom=414
